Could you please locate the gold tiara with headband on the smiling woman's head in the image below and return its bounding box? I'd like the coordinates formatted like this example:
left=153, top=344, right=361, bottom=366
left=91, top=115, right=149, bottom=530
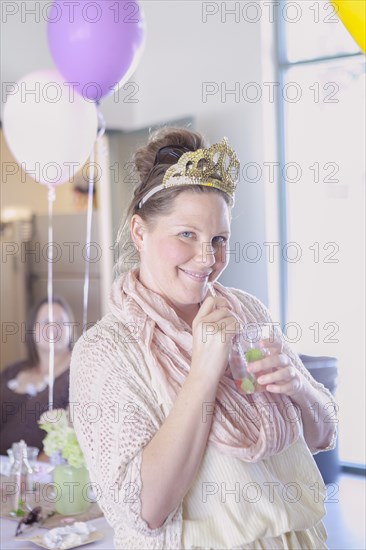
left=139, top=138, right=240, bottom=208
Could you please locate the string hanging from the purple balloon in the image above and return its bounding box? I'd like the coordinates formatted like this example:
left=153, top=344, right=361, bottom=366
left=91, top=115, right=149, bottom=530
left=83, top=105, right=106, bottom=334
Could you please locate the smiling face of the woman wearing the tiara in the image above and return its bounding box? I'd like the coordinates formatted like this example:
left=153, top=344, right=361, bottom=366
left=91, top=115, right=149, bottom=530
left=131, top=195, right=230, bottom=324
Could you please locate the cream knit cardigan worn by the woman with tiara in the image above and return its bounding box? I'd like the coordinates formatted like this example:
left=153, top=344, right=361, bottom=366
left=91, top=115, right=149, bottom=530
left=70, top=288, right=336, bottom=550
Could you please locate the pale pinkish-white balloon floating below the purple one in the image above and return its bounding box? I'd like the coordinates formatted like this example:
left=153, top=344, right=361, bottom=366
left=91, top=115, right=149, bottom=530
left=3, top=70, right=98, bottom=187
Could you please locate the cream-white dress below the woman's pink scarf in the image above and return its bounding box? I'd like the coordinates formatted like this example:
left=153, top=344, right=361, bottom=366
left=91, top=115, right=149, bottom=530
left=182, top=444, right=327, bottom=550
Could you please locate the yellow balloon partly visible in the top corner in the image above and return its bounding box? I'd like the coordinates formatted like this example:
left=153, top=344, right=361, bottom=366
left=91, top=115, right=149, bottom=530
left=332, top=0, right=366, bottom=52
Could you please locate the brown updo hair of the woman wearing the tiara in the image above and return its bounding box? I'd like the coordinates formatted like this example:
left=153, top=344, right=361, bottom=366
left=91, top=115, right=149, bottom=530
left=114, top=127, right=231, bottom=276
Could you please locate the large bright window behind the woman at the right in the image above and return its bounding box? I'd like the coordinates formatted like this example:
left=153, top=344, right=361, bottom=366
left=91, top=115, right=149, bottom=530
left=277, top=0, right=366, bottom=465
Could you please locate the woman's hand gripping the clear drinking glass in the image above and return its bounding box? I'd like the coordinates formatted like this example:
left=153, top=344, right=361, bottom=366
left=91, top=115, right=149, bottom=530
left=248, top=340, right=305, bottom=396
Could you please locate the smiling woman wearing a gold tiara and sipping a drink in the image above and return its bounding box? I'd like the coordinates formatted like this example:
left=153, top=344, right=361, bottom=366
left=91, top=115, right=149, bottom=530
left=70, top=128, right=335, bottom=549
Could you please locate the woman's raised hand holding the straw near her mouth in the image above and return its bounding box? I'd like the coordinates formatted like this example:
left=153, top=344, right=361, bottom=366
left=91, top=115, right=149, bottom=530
left=191, top=296, right=240, bottom=382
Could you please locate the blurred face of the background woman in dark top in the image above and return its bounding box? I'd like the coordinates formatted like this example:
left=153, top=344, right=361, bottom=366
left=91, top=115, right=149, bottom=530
left=34, top=303, right=72, bottom=353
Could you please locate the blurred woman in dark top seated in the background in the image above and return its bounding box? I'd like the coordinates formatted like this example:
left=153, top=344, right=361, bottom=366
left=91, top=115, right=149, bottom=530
left=1, top=297, right=74, bottom=454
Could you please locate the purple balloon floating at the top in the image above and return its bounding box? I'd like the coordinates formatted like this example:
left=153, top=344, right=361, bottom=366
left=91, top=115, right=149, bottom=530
left=48, top=0, right=145, bottom=101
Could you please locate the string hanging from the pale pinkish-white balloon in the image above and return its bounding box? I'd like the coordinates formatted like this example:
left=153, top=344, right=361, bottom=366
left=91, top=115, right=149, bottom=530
left=47, top=186, right=56, bottom=411
